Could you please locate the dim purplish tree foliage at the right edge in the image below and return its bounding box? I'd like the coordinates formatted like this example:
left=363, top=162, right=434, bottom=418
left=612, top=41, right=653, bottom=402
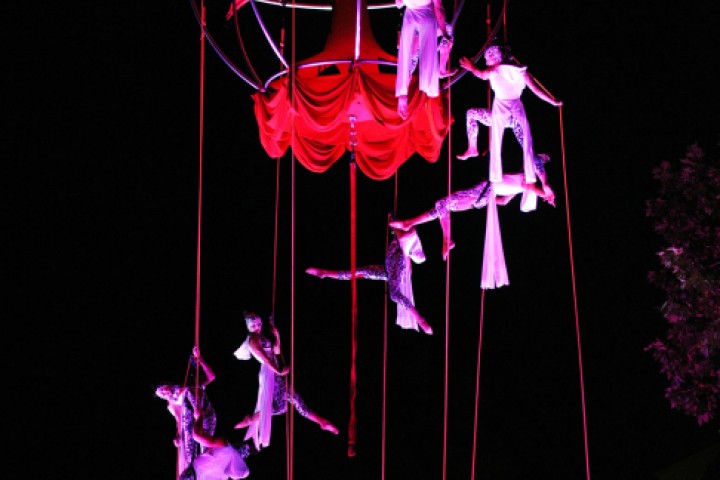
left=646, top=145, right=720, bottom=424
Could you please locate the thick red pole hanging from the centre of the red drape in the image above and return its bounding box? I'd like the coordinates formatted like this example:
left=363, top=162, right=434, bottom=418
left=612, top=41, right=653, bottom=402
left=348, top=115, right=357, bottom=457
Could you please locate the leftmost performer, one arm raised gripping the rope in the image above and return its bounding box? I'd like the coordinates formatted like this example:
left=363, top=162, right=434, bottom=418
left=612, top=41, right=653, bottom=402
left=155, top=347, right=217, bottom=478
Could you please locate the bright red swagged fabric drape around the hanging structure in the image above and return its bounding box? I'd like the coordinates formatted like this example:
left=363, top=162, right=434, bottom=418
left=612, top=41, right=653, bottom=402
left=253, top=64, right=450, bottom=180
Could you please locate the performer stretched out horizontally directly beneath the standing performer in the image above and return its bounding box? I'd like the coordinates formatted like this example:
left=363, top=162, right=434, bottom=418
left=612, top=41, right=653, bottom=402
left=389, top=154, right=555, bottom=260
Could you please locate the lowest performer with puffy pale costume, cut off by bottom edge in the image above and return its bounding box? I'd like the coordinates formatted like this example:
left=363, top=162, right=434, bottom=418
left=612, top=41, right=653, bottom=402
left=190, top=412, right=259, bottom=480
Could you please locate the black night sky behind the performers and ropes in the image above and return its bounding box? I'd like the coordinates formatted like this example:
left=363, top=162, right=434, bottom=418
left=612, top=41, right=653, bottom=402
left=8, top=0, right=720, bottom=479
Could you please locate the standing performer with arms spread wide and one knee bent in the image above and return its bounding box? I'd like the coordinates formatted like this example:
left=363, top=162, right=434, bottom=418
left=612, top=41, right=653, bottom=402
left=457, top=42, right=562, bottom=183
